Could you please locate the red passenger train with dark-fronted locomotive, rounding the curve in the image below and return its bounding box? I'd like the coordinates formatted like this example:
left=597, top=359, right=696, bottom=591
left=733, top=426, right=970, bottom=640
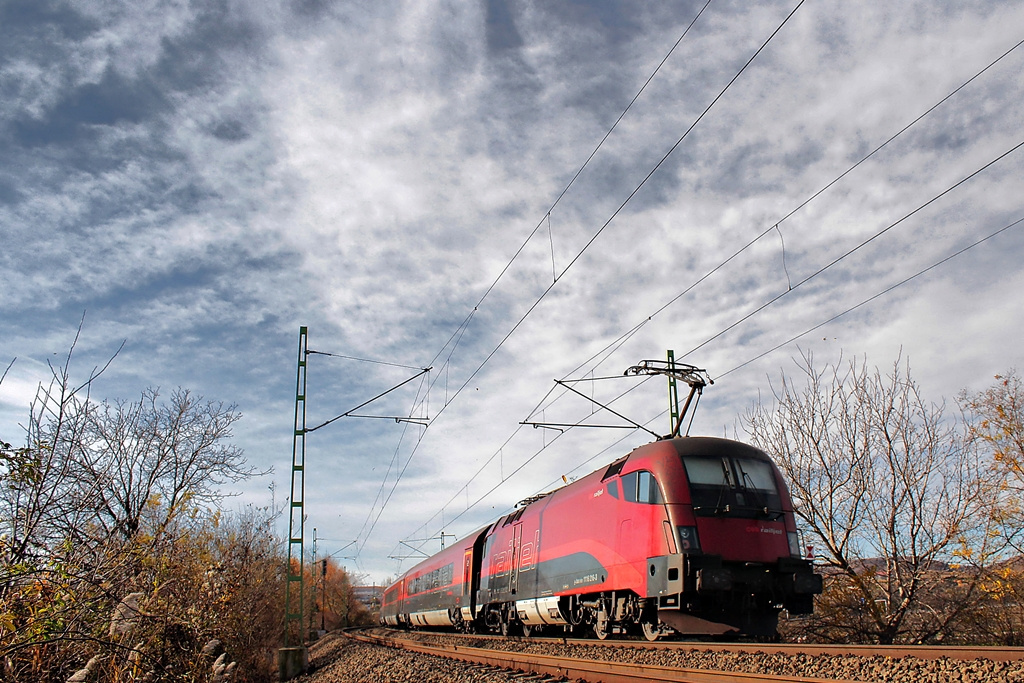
left=381, top=436, right=822, bottom=640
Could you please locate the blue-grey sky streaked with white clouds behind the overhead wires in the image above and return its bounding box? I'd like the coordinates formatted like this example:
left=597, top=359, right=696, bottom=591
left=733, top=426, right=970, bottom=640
left=0, top=0, right=1024, bottom=582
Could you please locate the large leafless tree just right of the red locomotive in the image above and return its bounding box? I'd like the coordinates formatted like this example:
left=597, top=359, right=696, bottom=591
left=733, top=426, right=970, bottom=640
left=744, top=354, right=997, bottom=643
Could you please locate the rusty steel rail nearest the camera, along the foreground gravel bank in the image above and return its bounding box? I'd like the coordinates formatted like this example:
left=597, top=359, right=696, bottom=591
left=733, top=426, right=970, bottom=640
left=345, top=632, right=853, bottom=683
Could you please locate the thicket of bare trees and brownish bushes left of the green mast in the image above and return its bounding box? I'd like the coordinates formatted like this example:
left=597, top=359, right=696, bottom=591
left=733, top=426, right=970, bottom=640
left=0, top=329, right=284, bottom=682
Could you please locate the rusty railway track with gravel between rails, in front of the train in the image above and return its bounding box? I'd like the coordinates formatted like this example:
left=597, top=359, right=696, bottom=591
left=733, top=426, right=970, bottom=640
left=346, top=630, right=1024, bottom=683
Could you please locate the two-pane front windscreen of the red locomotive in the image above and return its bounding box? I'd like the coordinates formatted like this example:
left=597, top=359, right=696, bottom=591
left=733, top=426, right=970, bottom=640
left=683, top=455, right=782, bottom=519
